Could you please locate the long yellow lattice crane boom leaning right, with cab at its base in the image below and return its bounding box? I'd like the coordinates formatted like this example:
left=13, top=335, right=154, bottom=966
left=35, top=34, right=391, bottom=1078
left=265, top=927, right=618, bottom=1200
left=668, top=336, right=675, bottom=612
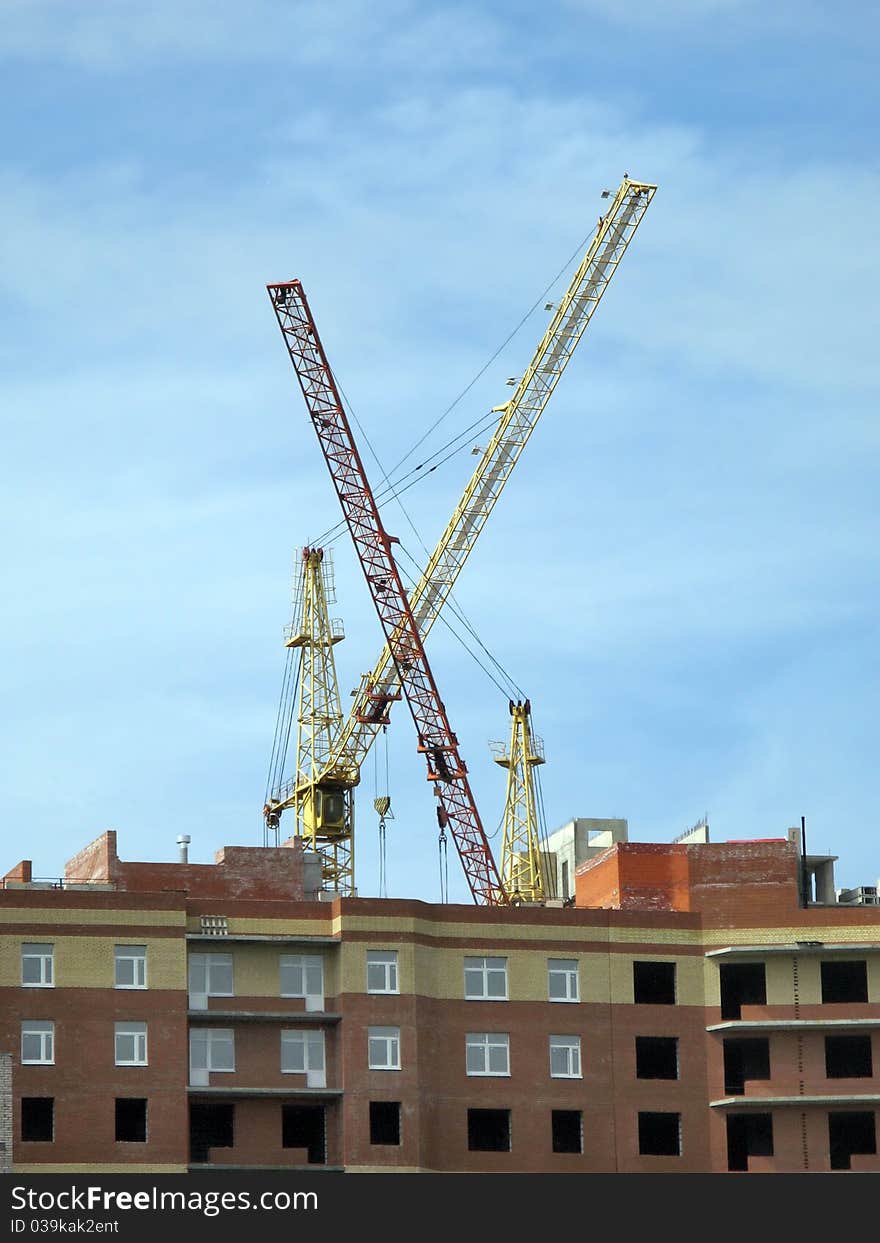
left=264, top=175, right=656, bottom=894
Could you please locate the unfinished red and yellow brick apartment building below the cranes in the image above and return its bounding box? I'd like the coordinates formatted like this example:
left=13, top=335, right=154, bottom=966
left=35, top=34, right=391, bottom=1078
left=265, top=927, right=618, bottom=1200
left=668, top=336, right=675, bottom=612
left=0, top=820, right=880, bottom=1172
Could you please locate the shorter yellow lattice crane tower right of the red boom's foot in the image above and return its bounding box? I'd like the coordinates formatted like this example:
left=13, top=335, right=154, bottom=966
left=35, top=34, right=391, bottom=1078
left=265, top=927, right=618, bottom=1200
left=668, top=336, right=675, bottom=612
left=491, top=700, right=551, bottom=902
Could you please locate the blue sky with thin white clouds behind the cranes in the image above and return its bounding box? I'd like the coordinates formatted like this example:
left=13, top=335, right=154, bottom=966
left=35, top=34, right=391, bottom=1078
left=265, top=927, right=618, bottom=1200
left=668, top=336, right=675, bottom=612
left=0, top=0, right=880, bottom=900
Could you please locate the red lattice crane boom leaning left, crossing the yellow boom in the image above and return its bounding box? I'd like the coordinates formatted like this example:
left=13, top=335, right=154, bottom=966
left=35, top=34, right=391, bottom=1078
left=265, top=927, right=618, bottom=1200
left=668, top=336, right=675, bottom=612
left=267, top=281, right=506, bottom=906
